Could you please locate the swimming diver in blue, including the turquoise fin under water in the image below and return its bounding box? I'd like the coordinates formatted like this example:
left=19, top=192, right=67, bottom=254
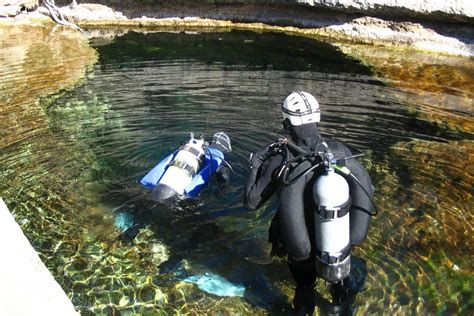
left=115, top=132, right=232, bottom=240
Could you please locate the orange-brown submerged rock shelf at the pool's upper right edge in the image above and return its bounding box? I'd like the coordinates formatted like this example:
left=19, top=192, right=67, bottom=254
left=339, top=44, right=474, bottom=133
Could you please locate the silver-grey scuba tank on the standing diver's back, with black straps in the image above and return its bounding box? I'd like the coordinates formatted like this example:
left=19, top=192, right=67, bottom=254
left=313, top=153, right=351, bottom=283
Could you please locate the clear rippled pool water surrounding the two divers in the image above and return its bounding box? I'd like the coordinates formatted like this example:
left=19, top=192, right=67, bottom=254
left=0, top=28, right=474, bottom=315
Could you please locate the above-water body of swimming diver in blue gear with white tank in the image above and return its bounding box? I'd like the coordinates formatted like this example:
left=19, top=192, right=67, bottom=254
left=140, top=132, right=232, bottom=202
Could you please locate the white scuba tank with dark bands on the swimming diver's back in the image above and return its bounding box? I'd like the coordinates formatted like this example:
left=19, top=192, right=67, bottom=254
left=152, top=133, right=204, bottom=200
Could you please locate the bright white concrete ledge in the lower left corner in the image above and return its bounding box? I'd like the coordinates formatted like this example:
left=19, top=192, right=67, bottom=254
left=0, top=198, right=79, bottom=316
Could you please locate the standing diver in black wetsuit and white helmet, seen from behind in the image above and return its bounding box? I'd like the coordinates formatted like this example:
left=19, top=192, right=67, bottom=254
left=244, top=91, right=375, bottom=314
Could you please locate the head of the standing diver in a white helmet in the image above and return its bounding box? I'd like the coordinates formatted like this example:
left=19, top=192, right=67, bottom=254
left=282, top=91, right=321, bottom=139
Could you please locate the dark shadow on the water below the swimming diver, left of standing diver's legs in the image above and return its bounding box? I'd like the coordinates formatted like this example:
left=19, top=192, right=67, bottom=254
left=107, top=184, right=292, bottom=314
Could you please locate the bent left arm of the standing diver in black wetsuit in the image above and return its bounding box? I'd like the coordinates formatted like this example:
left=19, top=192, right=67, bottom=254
left=244, top=148, right=283, bottom=210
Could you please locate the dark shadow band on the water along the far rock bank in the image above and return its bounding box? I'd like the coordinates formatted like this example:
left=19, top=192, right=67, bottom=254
left=97, top=31, right=375, bottom=74
